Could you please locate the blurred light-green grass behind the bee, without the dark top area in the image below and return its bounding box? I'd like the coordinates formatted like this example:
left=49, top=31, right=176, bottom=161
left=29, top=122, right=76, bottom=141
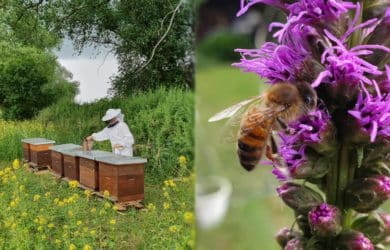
left=195, top=59, right=390, bottom=250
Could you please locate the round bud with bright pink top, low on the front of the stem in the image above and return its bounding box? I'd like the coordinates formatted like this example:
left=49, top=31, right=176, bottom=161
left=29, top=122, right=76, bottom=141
left=308, top=203, right=342, bottom=238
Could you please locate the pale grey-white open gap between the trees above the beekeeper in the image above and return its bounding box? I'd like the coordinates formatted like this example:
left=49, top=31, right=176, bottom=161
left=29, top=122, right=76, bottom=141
left=55, top=40, right=118, bottom=103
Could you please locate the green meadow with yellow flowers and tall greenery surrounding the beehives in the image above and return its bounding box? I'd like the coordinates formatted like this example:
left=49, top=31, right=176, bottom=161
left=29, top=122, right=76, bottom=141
left=0, top=89, right=195, bottom=250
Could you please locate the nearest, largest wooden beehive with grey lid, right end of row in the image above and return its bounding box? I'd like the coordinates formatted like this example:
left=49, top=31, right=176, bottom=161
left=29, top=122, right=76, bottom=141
left=96, top=154, right=147, bottom=202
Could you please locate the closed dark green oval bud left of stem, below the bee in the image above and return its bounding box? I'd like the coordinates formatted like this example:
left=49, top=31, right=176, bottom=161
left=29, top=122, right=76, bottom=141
left=276, top=182, right=323, bottom=211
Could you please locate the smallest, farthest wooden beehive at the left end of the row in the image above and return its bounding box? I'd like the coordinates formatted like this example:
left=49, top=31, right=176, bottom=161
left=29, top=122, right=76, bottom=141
left=22, top=138, right=55, bottom=167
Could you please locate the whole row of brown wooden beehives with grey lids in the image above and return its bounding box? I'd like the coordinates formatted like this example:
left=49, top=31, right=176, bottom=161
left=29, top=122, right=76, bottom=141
left=22, top=138, right=147, bottom=202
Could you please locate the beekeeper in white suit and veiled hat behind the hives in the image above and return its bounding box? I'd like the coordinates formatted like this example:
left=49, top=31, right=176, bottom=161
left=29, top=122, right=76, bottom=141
left=87, top=109, right=134, bottom=156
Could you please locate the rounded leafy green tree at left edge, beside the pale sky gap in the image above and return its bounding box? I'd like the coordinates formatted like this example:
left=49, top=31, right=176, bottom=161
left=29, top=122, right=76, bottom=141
left=0, top=43, right=76, bottom=120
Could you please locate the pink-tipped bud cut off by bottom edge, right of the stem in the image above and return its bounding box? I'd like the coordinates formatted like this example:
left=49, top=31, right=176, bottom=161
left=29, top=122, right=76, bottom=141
left=337, top=230, right=374, bottom=250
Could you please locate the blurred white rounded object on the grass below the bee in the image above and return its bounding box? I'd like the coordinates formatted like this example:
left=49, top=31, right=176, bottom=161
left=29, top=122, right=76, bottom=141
left=195, top=176, right=232, bottom=229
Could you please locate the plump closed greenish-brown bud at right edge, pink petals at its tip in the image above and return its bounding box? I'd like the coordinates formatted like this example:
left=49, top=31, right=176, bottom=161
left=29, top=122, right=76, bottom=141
left=345, top=176, right=390, bottom=213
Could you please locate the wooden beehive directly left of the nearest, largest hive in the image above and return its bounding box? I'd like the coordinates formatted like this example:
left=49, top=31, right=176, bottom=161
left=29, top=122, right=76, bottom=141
left=77, top=150, right=113, bottom=190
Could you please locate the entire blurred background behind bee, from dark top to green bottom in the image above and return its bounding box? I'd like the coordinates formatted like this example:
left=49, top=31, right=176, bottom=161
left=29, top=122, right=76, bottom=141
left=195, top=0, right=390, bottom=250
